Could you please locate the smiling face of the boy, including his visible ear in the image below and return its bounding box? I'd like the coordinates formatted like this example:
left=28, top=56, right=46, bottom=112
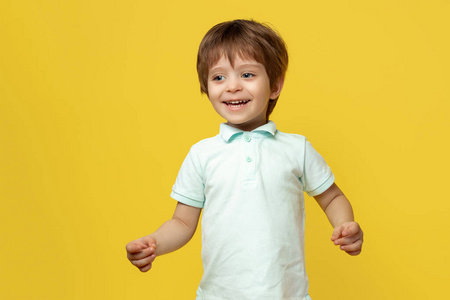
left=208, top=56, right=280, bottom=131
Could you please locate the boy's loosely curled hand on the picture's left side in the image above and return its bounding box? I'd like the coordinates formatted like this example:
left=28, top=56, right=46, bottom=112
left=126, top=236, right=156, bottom=272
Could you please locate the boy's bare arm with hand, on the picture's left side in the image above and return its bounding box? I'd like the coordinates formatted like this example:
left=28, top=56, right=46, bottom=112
left=126, top=202, right=201, bottom=272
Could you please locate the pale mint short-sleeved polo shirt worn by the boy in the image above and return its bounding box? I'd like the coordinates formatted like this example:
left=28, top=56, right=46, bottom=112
left=171, top=121, right=334, bottom=300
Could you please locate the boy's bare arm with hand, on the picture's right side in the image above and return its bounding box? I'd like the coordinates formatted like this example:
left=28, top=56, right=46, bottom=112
left=314, top=183, right=363, bottom=255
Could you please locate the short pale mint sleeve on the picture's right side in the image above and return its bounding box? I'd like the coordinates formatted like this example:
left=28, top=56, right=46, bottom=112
left=301, top=141, right=334, bottom=196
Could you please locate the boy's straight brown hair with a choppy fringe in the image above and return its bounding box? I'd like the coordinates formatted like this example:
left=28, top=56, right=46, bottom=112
left=197, top=20, right=288, bottom=118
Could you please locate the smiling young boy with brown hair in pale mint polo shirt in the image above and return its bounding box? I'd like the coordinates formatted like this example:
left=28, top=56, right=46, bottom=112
left=126, top=20, right=363, bottom=300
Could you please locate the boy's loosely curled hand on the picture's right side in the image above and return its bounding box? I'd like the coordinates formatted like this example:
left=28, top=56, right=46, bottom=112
left=331, top=222, right=363, bottom=255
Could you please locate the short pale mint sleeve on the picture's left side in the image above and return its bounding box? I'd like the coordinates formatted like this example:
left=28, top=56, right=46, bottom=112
left=170, top=147, right=205, bottom=208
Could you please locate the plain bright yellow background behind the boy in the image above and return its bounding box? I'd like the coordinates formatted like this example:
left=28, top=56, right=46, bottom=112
left=0, top=0, right=450, bottom=300
